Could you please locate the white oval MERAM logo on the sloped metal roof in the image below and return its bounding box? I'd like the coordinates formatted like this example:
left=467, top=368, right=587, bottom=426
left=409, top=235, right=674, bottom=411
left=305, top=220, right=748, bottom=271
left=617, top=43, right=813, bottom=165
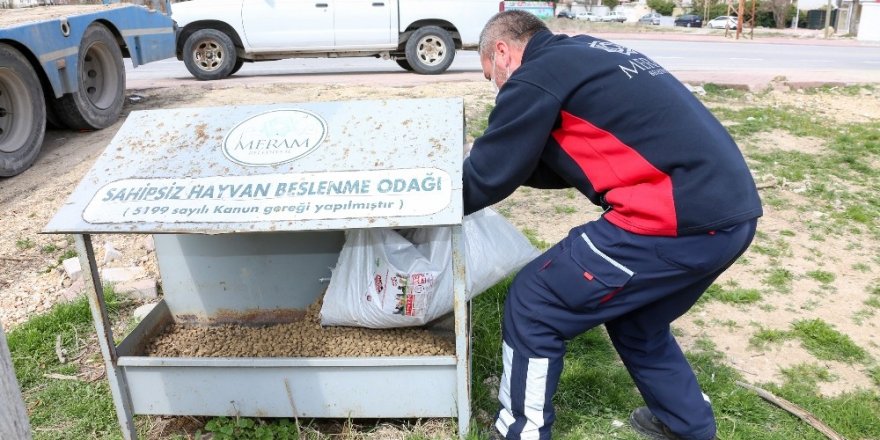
left=223, top=109, right=327, bottom=166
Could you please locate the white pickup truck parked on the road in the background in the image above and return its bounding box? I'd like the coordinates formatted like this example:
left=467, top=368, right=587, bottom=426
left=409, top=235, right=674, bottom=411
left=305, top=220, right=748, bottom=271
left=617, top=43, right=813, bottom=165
left=172, top=0, right=504, bottom=80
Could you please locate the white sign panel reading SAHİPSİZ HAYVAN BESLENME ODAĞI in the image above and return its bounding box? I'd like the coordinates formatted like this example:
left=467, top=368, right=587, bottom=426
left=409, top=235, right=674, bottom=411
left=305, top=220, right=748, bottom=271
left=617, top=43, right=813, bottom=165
left=83, top=168, right=452, bottom=223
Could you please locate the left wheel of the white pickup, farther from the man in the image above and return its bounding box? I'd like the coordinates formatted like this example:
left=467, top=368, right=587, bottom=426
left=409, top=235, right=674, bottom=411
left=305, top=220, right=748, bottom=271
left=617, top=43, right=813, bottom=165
left=183, top=29, right=241, bottom=81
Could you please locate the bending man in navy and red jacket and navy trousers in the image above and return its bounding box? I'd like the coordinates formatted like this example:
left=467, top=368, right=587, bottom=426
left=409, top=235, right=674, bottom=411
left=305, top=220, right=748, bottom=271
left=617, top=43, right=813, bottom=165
left=464, top=11, right=762, bottom=440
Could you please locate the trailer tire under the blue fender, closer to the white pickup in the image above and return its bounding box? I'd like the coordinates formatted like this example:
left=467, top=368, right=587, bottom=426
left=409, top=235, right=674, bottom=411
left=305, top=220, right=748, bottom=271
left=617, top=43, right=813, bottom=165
left=53, top=23, right=125, bottom=130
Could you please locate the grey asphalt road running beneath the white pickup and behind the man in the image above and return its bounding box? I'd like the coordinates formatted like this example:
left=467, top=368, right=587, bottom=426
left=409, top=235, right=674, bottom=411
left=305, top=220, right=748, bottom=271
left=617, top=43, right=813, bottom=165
left=127, top=36, right=880, bottom=89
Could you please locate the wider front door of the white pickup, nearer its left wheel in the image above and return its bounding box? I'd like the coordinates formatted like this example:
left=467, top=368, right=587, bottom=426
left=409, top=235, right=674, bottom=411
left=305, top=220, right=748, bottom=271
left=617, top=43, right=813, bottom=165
left=241, top=0, right=335, bottom=50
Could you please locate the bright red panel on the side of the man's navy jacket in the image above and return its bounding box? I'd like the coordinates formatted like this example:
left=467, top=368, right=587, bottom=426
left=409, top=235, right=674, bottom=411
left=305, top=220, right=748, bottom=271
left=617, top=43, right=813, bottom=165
left=553, top=111, right=678, bottom=236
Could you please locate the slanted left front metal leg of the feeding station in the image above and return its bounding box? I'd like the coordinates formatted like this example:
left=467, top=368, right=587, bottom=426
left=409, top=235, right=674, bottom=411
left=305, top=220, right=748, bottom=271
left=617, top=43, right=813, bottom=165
left=74, top=234, right=137, bottom=440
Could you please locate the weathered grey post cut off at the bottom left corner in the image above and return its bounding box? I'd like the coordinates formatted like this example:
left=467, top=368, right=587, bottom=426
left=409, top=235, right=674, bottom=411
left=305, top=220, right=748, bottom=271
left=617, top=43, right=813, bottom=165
left=0, top=323, right=31, bottom=440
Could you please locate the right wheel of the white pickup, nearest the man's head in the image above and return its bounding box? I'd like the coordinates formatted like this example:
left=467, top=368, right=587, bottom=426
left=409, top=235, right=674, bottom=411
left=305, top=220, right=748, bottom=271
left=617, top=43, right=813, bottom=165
left=406, top=26, right=455, bottom=75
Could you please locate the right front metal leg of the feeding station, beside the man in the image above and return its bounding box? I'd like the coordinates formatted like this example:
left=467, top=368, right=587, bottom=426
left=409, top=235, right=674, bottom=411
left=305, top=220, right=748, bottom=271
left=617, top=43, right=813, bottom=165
left=452, top=225, right=471, bottom=438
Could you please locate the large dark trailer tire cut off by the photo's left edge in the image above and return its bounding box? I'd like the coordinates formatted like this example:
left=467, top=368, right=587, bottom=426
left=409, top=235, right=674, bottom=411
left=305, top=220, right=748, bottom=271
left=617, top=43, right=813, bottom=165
left=0, top=44, right=46, bottom=177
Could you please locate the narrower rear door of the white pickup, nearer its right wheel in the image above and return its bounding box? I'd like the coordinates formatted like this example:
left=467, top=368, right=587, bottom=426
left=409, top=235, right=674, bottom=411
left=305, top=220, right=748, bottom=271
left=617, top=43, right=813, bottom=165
left=333, top=0, right=397, bottom=48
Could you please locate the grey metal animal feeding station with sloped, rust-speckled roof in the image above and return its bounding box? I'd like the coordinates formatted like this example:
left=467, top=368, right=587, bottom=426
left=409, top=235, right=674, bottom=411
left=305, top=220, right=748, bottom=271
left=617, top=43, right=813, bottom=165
left=44, top=99, right=471, bottom=439
